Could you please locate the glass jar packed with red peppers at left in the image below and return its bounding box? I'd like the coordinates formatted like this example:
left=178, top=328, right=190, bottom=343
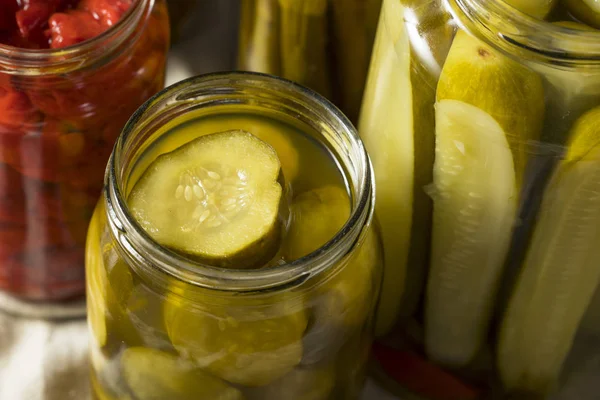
left=0, top=0, right=169, bottom=301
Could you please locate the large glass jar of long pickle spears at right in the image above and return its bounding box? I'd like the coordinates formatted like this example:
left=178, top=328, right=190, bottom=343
left=359, top=0, right=600, bottom=399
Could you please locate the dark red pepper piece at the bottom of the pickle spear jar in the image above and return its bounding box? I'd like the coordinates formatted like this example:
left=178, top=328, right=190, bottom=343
left=373, top=343, right=481, bottom=400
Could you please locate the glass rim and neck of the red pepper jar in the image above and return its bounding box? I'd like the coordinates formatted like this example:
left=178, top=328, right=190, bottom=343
left=0, top=0, right=152, bottom=76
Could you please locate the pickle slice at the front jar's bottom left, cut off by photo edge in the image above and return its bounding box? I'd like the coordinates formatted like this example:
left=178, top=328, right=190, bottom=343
left=121, top=347, right=243, bottom=400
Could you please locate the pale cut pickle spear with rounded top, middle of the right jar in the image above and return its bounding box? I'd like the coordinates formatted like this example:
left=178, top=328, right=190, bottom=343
left=425, top=100, right=517, bottom=366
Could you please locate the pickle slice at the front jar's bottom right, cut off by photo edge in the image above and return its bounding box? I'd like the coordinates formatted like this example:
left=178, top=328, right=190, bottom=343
left=245, top=365, right=335, bottom=400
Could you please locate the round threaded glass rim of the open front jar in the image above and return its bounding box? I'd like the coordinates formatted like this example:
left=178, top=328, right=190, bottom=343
left=105, top=72, right=375, bottom=291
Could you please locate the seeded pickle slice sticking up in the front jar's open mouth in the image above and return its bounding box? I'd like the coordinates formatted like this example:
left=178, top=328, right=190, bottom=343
left=129, top=130, right=282, bottom=268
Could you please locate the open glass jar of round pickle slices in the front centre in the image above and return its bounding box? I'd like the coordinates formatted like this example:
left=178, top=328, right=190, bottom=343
left=86, top=73, right=381, bottom=400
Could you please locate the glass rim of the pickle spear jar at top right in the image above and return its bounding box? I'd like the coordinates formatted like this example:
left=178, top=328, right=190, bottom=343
left=444, top=0, right=600, bottom=68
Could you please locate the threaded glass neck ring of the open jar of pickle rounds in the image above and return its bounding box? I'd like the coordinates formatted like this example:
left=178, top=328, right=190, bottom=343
left=105, top=73, right=374, bottom=291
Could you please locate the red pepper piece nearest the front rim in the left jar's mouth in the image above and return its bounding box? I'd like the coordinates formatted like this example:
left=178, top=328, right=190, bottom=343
left=47, top=10, right=106, bottom=49
